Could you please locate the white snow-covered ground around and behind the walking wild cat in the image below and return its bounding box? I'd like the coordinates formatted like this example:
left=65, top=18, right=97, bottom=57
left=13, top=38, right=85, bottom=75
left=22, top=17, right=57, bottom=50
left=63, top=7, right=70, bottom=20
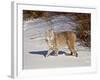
left=23, top=16, right=91, bottom=69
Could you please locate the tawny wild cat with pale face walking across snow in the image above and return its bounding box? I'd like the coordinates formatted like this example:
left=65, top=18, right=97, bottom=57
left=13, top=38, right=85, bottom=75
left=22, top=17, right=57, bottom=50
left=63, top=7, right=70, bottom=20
left=45, top=30, right=78, bottom=57
